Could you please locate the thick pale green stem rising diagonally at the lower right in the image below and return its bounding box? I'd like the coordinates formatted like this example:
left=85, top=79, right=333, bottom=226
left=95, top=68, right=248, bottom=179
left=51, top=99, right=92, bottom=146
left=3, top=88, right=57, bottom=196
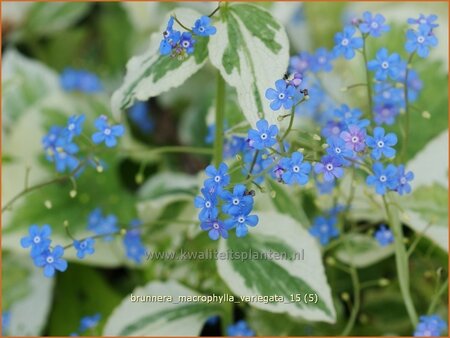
left=383, top=196, right=417, bottom=327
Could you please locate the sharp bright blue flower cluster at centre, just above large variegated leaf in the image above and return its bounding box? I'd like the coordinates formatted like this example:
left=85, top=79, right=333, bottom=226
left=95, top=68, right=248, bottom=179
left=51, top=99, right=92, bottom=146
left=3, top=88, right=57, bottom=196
left=194, top=163, right=258, bottom=240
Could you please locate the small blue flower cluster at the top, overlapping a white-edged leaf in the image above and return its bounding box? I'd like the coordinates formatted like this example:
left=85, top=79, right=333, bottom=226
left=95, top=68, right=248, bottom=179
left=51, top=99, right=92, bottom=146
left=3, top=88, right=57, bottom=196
left=159, top=15, right=216, bottom=60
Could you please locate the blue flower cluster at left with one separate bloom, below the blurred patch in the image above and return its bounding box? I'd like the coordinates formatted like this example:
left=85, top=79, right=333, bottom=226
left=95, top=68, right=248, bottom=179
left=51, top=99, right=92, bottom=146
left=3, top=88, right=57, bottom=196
left=42, top=114, right=125, bottom=173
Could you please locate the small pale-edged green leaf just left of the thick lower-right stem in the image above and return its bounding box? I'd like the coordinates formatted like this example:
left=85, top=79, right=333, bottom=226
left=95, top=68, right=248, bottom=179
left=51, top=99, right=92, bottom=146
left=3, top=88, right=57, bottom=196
left=336, top=234, right=394, bottom=268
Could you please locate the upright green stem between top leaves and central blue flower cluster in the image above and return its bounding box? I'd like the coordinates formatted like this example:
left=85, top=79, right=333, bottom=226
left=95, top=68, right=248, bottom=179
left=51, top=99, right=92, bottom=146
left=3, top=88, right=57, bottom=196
left=214, top=71, right=225, bottom=168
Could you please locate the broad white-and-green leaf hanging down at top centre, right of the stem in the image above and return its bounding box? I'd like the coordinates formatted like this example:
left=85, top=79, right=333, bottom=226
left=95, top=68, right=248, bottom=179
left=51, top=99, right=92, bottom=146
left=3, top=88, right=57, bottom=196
left=208, top=3, right=289, bottom=125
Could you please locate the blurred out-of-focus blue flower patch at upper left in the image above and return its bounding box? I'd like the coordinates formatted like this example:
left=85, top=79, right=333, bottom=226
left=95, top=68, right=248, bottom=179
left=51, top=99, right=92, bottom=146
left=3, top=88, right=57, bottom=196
left=59, top=68, right=103, bottom=93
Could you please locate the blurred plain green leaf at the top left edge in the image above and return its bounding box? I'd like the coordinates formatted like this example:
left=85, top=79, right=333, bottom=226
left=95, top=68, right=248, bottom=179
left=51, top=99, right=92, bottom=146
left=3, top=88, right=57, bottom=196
left=23, top=2, right=91, bottom=36
